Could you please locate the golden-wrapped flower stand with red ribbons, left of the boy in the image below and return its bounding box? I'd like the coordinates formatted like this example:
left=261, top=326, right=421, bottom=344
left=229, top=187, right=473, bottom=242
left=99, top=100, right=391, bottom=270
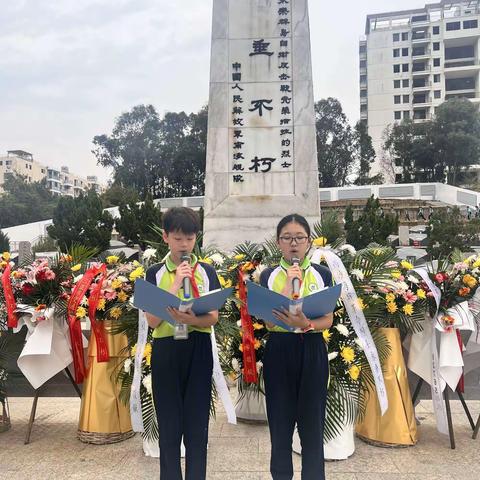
left=77, top=326, right=135, bottom=445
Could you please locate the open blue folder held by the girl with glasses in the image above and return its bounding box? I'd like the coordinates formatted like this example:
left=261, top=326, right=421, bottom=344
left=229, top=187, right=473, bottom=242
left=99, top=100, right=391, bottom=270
left=247, top=281, right=342, bottom=332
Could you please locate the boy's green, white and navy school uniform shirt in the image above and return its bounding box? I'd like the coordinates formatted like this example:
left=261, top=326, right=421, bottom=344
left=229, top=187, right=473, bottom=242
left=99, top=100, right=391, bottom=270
left=145, top=255, right=220, bottom=338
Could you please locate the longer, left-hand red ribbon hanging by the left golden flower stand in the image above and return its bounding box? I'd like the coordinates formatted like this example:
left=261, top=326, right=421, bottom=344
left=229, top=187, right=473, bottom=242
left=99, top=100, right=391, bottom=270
left=67, top=267, right=101, bottom=383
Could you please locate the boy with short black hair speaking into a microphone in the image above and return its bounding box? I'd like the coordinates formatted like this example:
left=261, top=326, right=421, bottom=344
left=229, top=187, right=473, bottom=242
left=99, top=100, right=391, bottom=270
left=146, top=207, right=220, bottom=480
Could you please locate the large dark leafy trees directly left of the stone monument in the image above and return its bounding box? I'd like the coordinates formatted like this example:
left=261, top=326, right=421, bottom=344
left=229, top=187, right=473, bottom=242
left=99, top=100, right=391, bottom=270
left=93, top=105, right=208, bottom=199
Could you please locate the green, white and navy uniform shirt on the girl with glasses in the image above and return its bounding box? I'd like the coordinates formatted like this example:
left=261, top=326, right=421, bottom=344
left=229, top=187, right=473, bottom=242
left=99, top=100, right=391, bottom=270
left=260, top=258, right=332, bottom=333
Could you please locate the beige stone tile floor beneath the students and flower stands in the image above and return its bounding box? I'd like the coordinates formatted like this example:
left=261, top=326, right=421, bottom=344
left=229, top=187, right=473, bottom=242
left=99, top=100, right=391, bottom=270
left=0, top=398, right=480, bottom=480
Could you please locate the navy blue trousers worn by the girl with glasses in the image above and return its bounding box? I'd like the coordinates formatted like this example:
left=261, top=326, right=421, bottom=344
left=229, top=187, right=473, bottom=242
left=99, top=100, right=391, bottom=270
left=263, top=333, right=329, bottom=480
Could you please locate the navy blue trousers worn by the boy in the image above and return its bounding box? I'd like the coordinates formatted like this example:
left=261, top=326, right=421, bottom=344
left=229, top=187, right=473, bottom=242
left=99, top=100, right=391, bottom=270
left=152, top=332, right=213, bottom=480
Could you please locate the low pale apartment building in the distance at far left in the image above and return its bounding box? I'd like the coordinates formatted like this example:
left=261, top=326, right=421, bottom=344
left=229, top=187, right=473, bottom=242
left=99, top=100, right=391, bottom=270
left=0, top=150, right=104, bottom=197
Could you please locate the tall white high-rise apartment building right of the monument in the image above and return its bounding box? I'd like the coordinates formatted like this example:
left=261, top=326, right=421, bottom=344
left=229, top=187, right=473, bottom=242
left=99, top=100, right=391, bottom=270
left=359, top=0, right=480, bottom=181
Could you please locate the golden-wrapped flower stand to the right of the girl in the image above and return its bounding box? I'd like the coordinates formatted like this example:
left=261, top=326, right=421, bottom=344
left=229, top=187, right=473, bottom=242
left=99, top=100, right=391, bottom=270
left=356, top=328, right=418, bottom=447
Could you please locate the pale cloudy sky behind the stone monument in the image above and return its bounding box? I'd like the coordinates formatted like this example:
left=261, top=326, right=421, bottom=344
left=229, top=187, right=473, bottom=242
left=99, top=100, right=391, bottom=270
left=0, top=0, right=425, bottom=182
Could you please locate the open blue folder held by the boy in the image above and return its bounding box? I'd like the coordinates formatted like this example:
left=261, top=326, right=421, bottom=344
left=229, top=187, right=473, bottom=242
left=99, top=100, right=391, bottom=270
left=133, top=279, right=233, bottom=325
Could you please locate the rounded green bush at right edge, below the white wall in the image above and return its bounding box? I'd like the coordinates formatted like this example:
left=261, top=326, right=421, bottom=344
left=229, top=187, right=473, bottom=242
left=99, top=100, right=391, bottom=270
left=426, top=207, right=480, bottom=258
